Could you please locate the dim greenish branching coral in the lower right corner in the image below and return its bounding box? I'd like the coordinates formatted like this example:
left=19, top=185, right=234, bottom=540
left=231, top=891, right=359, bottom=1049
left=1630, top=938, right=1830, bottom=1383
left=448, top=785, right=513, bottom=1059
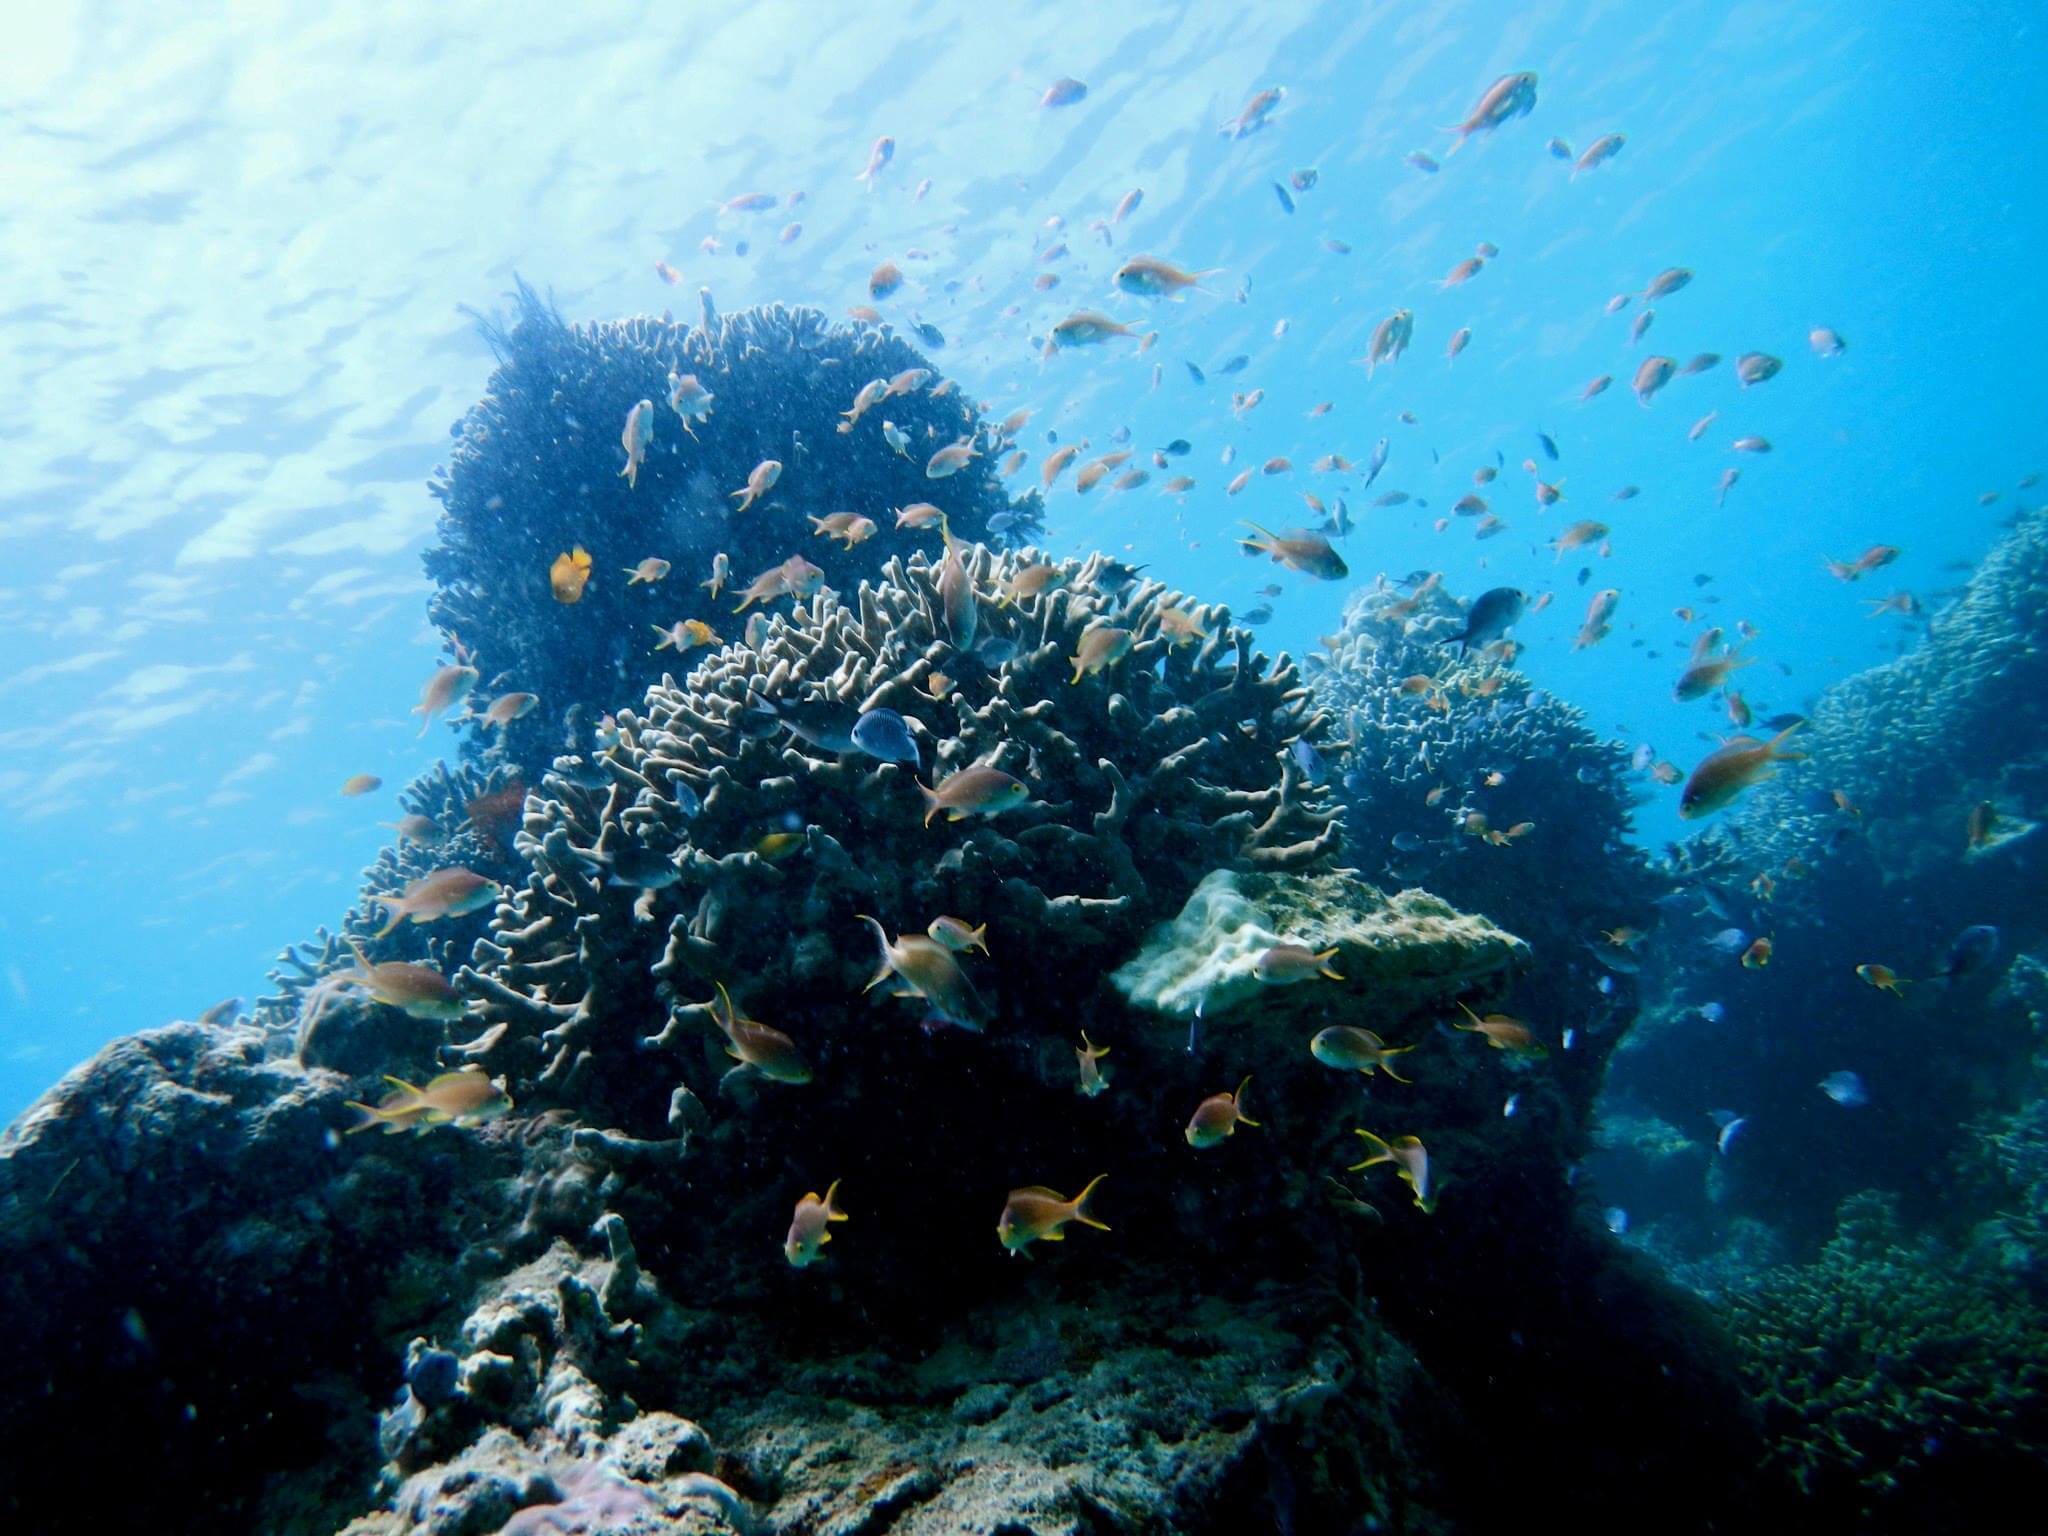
left=1724, top=1190, right=2048, bottom=1530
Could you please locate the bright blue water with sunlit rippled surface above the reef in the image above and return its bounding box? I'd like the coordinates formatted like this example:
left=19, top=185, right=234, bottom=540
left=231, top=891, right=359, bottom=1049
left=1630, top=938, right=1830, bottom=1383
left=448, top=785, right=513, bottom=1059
left=0, top=4, right=2048, bottom=1114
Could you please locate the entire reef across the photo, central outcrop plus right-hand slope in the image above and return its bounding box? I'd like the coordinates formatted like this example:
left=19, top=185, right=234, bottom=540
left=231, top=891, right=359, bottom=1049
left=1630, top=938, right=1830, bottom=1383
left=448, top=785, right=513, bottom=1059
left=0, top=289, right=2048, bottom=1536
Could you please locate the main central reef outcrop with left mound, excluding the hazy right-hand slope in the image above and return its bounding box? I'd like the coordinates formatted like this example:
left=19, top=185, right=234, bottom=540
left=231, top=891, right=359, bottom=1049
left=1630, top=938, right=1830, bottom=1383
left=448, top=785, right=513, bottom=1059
left=0, top=293, right=1755, bottom=1536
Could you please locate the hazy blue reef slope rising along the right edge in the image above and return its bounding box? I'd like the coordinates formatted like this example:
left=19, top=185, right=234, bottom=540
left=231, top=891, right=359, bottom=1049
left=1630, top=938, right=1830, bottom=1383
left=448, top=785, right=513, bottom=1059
left=1610, top=512, right=2048, bottom=1245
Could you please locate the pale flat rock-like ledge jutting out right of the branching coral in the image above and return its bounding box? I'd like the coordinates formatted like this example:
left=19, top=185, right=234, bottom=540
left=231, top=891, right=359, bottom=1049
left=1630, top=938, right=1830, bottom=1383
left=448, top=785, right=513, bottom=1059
left=1110, top=870, right=1528, bottom=1028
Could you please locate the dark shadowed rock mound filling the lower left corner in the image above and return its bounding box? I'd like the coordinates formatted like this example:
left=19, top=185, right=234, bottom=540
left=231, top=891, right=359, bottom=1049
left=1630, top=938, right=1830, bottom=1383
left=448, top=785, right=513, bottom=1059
left=0, top=1024, right=516, bottom=1532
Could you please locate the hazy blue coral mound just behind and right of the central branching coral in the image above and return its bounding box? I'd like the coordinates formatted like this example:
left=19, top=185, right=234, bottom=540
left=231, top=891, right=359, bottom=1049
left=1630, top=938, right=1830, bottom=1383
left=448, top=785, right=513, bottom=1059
left=1303, top=578, right=1669, bottom=1155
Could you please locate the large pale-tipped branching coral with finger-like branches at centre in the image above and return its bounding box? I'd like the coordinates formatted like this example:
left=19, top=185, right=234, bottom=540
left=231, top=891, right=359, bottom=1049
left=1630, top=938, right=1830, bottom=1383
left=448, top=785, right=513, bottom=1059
left=465, top=549, right=1337, bottom=1090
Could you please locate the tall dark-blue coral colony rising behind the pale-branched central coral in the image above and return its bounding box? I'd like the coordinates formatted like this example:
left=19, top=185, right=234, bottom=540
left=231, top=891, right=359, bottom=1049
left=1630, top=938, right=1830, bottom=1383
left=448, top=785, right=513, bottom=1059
left=426, top=283, right=1038, bottom=776
